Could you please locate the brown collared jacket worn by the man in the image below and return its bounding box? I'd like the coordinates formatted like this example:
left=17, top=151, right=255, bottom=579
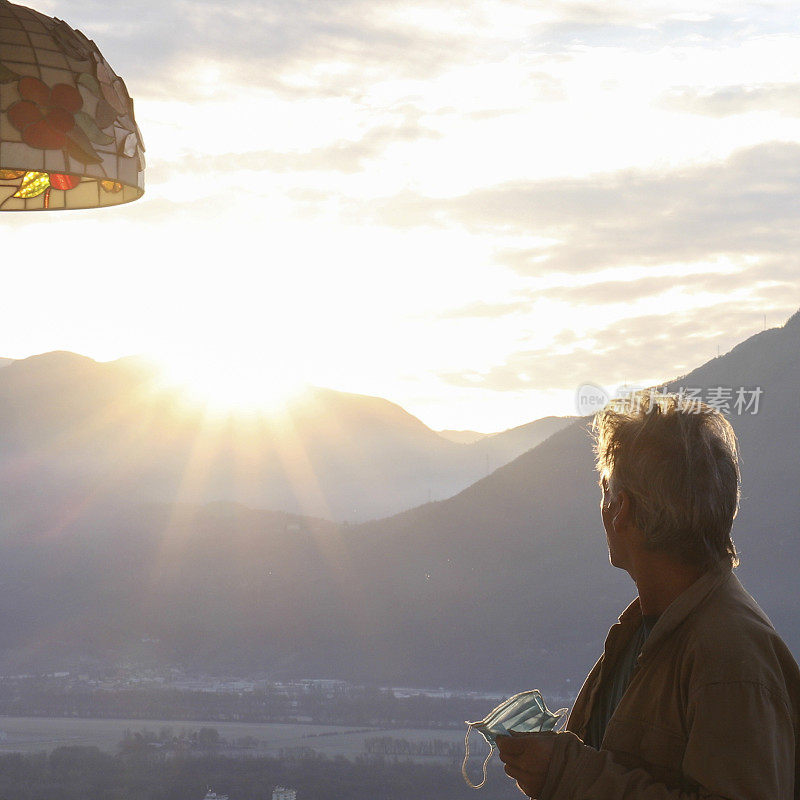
left=539, top=564, right=800, bottom=800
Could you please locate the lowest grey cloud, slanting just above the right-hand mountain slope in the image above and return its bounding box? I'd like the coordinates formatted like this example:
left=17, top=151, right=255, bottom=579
left=438, top=304, right=796, bottom=392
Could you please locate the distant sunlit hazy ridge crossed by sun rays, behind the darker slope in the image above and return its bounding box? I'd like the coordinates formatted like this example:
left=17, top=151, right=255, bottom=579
left=0, top=352, right=566, bottom=521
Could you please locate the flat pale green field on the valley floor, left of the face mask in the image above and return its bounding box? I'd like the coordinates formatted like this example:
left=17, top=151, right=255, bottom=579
left=0, top=717, right=468, bottom=758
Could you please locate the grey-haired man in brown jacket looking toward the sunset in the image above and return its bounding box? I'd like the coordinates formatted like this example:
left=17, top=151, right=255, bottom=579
left=497, top=393, right=800, bottom=800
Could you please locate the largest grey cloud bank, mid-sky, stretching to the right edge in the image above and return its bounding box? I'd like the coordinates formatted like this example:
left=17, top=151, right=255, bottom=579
left=364, top=142, right=800, bottom=275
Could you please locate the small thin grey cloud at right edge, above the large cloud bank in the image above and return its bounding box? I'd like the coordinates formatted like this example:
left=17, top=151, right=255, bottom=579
left=658, top=83, right=800, bottom=117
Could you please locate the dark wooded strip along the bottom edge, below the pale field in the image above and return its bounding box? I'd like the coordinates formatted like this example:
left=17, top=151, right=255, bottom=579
left=0, top=747, right=519, bottom=800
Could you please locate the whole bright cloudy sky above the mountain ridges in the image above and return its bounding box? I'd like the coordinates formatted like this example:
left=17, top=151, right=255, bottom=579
left=0, top=0, right=800, bottom=431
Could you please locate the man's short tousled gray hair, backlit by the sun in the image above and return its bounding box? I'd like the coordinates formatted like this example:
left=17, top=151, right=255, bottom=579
left=593, top=391, right=741, bottom=569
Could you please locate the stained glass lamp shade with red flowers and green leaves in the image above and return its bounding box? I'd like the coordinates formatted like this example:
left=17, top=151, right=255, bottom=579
left=0, top=0, right=145, bottom=211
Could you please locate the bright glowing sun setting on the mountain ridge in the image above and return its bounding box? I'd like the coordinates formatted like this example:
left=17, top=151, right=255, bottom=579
left=154, top=354, right=308, bottom=416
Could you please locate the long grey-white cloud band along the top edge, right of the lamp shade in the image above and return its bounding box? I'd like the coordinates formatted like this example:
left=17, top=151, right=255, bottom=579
left=51, top=0, right=776, bottom=98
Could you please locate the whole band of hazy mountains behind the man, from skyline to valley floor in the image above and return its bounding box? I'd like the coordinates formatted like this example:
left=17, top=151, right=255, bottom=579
left=0, top=314, right=800, bottom=694
